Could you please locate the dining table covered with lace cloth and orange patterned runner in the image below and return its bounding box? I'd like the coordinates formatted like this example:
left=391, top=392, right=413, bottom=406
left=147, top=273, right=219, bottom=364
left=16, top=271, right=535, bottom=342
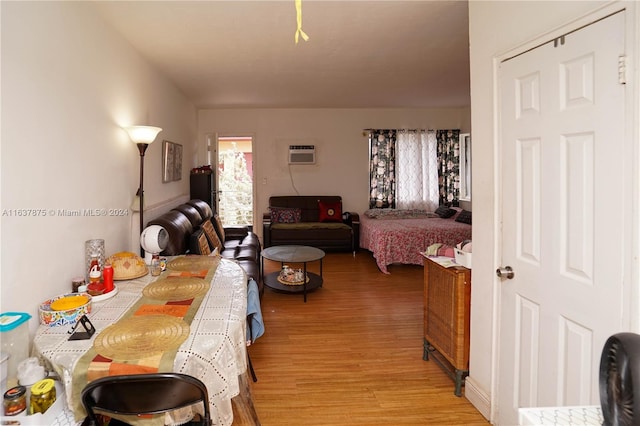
left=33, top=255, right=257, bottom=426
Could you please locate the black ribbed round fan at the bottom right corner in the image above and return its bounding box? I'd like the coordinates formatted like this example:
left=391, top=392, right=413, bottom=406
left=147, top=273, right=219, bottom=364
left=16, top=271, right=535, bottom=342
left=600, top=333, right=640, bottom=426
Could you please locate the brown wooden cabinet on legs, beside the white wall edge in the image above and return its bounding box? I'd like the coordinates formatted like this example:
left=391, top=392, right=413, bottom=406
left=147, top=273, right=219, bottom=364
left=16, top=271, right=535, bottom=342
left=423, top=258, right=471, bottom=396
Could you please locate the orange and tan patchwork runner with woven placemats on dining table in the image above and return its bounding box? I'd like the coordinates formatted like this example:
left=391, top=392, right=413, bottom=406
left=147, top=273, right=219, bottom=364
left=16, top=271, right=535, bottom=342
left=71, top=257, right=220, bottom=420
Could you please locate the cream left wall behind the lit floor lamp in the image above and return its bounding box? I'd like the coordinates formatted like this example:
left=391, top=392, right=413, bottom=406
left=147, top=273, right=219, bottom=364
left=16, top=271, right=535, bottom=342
left=0, top=2, right=196, bottom=330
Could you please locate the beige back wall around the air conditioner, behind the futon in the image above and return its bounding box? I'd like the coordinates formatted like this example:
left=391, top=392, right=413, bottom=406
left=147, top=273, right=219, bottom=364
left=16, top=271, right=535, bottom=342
left=198, top=108, right=470, bottom=240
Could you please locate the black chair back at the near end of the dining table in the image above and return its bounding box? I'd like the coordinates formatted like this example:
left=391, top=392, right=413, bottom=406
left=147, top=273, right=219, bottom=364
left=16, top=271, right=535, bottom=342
left=82, top=373, right=212, bottom=426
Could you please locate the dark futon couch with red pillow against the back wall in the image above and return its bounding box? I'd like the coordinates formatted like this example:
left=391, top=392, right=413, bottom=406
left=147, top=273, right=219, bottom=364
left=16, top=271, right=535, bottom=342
left=262, top=195, right=360, bottom=253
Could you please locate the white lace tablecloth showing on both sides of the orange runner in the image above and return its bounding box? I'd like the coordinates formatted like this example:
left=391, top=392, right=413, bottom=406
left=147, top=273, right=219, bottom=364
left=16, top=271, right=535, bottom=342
left=34, top=259, right=247, bottom=426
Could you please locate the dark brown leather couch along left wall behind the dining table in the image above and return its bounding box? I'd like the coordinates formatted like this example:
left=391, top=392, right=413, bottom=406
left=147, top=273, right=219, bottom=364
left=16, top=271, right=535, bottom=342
left=147, top=199, right=263, bottom=294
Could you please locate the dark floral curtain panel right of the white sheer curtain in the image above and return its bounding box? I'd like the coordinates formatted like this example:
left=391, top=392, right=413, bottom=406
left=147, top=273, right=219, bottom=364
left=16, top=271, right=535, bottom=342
left=436, top=129, right=460, bottom=206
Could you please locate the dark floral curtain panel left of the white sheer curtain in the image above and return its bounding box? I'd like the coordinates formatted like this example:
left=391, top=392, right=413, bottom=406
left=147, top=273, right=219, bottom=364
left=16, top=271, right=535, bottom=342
left=369, top=130, right=396, bottom=209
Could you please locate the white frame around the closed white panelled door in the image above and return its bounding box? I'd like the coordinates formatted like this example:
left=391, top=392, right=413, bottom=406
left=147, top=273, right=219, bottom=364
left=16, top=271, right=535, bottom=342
left=488, top=2, right=640, bottom=423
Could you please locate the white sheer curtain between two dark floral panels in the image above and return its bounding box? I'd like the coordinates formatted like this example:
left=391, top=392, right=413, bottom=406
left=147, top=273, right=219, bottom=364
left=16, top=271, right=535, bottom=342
left=396, top=130, right=439, bottom=211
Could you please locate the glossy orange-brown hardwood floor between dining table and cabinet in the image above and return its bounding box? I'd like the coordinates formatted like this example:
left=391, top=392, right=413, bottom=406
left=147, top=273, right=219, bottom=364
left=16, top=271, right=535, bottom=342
left=242, top=250, right=489, bottom=426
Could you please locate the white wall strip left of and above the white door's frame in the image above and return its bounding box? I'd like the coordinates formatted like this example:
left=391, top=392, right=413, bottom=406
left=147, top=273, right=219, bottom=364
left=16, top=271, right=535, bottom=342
left=465, top=0, right=632, bottom=417
